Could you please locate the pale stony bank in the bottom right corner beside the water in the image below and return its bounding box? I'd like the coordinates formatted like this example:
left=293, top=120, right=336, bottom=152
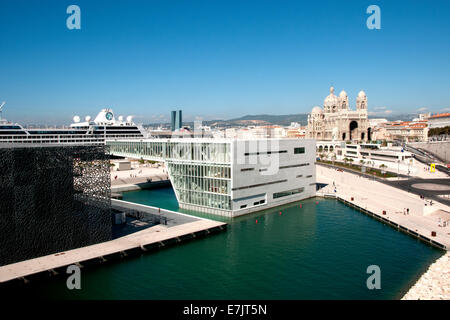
left=402, top=252, right=450, bottom=300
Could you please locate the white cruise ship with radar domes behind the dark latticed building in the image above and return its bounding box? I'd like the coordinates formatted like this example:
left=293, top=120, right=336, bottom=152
left=0, top=109, right=148, bottom=145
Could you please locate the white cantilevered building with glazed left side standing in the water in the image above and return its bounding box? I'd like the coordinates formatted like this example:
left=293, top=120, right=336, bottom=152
left=106, top=138, right=316, bottom=217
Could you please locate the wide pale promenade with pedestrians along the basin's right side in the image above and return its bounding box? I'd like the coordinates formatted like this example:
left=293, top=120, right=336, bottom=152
left=317, top=165, right=450, bottom=250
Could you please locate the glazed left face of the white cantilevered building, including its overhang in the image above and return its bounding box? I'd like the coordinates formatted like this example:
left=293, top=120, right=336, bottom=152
left=107, top=140, right=231, bottom=210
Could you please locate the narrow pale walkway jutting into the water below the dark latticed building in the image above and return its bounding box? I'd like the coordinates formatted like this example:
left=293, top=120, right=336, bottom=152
left=0, top=201, right=226, bottom=283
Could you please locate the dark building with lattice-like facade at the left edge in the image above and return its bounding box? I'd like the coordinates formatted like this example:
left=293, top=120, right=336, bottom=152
left=0, top=144, right=112, bottom=265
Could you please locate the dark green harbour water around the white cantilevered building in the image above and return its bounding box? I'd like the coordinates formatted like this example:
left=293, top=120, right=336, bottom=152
left=15, top=189, right=443, bottom=299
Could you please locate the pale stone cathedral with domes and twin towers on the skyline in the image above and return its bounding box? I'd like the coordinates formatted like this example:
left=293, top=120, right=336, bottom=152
left=307, top=87, right=371, bottom=141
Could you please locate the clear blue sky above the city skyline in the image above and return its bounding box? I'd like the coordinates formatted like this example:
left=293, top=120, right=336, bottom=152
left=0, top=0, right=450, bottom=124
